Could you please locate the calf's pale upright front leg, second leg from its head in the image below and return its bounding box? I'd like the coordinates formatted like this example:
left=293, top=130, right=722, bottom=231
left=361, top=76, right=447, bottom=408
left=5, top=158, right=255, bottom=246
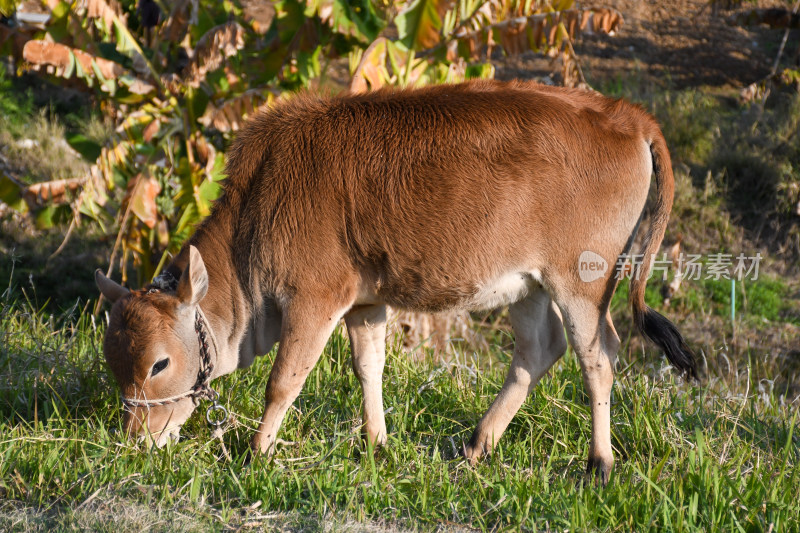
left=344, top=305, right=386, bottom=445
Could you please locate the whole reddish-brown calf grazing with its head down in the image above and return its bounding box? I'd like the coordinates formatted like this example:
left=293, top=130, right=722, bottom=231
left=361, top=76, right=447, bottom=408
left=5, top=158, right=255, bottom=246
left=97, top=81, right=695, bottom=479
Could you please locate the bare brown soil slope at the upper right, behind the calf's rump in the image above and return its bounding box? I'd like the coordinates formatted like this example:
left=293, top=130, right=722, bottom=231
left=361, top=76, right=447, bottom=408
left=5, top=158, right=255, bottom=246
left=496, top=0, right=800, bottom=89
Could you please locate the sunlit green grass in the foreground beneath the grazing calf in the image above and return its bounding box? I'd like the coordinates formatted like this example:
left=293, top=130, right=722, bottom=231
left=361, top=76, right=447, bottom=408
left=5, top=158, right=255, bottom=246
left=0, top=290, right=800, bottom=531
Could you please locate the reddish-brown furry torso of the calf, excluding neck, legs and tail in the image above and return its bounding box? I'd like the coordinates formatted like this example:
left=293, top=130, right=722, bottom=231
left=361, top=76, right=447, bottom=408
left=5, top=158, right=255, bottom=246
left=216, top=82, right=657, bottom=311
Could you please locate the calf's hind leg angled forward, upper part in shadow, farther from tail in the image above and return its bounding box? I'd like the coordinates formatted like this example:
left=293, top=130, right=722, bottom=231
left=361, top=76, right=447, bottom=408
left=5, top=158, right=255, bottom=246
left=464, top=291, right=567, bottom=463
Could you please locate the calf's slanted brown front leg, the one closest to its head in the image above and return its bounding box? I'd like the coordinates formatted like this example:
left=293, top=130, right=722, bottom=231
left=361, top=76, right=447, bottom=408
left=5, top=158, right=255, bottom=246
left=252, top=298, right=349, bottom=455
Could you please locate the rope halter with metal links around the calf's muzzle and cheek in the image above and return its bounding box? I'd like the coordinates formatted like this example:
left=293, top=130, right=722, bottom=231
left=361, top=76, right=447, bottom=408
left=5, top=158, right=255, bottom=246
left=120, top=287, right=228, bottom=428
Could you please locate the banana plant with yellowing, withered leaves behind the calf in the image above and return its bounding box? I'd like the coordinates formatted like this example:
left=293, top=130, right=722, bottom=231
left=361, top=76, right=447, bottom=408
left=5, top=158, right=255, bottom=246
left=0, top=0, right=622, bottom=285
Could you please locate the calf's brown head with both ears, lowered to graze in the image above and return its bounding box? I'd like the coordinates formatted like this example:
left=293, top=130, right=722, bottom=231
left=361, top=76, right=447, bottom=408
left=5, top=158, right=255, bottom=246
left=95, top=246, right=209, bottom=446
